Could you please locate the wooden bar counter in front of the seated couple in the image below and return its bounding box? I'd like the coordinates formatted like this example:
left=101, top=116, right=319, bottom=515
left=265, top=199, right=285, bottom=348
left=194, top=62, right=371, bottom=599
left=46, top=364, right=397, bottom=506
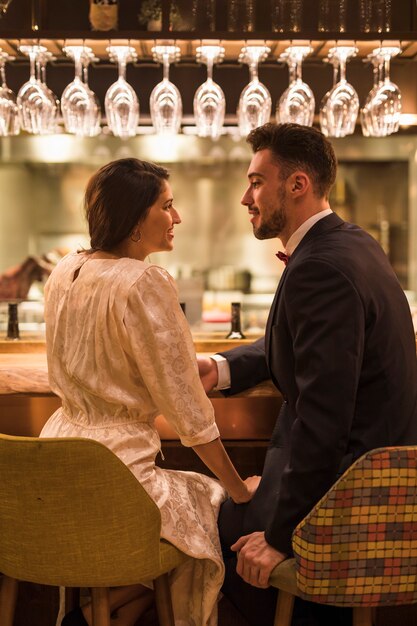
left=0, top=334, right=281, bottom=445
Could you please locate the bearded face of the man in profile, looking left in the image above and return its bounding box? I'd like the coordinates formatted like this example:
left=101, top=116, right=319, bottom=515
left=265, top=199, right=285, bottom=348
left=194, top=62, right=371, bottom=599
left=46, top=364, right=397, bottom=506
left=241, top=150, right=287, bottom=239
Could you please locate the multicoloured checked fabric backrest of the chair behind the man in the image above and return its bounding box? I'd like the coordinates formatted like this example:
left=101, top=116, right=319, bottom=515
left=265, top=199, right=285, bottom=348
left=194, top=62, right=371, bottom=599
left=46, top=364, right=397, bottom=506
left=293, top=446, right=417, bottom=606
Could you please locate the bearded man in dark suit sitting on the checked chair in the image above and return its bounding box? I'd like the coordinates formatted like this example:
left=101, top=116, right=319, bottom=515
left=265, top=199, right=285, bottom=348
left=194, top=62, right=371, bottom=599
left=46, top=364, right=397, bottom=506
left=199, top=124, right=417, bottom=626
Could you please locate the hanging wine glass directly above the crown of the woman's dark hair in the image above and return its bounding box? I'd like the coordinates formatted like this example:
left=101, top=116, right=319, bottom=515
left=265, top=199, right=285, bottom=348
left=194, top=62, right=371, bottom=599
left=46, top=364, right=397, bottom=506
left=104, top=46, right=139, bottom=138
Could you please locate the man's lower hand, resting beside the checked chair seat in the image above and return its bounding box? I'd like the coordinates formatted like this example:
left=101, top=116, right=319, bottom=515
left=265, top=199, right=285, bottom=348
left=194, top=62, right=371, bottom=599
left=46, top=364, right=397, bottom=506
left=231, top=532, right=287, bottom=589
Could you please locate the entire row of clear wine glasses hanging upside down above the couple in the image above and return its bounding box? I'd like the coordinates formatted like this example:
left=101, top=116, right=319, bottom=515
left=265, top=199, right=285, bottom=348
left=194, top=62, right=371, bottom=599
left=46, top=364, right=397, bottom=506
left=0, top=44, right=401, bottom=139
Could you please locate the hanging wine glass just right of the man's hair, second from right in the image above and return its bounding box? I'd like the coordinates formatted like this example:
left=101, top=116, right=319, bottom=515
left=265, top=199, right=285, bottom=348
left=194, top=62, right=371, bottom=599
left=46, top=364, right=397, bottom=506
left=320, top=46, right=359, bottom=137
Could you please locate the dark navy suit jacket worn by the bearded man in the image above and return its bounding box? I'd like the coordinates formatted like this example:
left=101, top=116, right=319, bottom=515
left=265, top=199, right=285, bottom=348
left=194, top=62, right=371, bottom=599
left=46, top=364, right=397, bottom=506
left=219, top=213, right=417, bottom=554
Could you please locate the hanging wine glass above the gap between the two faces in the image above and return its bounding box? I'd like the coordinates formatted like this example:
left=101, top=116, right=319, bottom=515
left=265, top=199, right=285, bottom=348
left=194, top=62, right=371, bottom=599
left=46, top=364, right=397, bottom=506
left=194, top=45, right=226, bottom=139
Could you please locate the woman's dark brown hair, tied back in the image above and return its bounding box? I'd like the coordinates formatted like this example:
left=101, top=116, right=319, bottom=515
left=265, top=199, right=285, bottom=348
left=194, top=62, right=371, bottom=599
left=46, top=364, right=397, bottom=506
left=84, top=159, right=169, bottom=251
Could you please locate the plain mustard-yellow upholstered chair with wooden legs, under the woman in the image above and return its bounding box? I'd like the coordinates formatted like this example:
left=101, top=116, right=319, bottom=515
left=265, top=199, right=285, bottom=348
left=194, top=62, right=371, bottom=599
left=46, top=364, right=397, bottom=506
left=0, top=435, right=188, bottom=626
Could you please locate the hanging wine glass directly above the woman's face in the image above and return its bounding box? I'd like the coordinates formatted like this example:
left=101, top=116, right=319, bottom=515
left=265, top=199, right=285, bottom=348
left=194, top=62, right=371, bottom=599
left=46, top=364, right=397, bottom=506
left=149, top=46, right=182, bottom=135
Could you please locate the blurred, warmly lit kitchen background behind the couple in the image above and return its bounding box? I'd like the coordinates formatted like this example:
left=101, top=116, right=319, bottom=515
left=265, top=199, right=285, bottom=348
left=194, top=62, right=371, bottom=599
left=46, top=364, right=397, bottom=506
left=0, top=134, right=417, bottom=334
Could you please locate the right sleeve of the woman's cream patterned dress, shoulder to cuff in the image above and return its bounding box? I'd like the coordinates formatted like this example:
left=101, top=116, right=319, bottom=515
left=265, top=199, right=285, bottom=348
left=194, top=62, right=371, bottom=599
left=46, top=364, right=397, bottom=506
left=124, top=266, right=219, bottom=446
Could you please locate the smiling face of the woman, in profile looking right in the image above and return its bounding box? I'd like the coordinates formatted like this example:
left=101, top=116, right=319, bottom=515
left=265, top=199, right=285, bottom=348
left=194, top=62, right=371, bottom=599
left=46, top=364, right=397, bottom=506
left=139, top=180, right=181, bottom=259
